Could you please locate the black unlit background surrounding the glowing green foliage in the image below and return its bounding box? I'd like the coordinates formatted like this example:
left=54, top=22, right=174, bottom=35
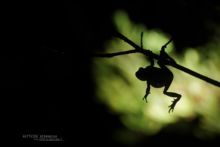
left=0, top=0, right=220, bottom=146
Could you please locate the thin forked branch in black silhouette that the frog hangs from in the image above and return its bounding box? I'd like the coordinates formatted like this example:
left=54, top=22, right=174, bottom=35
left=95, top=32, right=220, bottom=87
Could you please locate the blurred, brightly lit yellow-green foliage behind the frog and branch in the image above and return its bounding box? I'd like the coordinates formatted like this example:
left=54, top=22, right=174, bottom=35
left=93, top=10, right=220, bottom=145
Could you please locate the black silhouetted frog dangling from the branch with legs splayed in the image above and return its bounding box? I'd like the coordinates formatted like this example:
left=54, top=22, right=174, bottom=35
left=135, top=48, right=181, bottom=113
